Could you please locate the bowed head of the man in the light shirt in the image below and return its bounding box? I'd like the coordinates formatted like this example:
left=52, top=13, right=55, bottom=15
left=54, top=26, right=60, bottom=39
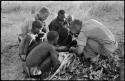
left=69, top=19, right=82, bottom=34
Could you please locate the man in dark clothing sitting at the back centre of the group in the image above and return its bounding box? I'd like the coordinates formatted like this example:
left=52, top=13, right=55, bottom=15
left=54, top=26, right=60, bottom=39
left=49, top=10, right=72, bottom=46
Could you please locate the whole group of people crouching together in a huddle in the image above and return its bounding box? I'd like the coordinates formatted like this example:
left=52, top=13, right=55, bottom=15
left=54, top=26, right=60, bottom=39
left=18, top=7, right=117, bottom=77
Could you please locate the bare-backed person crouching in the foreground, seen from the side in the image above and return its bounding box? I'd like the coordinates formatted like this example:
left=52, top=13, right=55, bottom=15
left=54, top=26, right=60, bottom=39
left=26, top=31, right=60, bottom=76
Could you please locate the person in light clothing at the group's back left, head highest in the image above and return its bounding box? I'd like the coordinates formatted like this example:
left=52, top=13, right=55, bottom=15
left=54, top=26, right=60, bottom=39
left=18, top=7, right=50, bottom=43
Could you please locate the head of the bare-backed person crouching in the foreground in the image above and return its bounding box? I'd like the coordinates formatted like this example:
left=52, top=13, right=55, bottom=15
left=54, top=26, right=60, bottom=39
left=47, top=31, right=59, bottom=45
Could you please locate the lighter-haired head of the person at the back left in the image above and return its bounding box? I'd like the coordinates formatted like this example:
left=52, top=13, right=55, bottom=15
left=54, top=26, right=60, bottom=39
left=36, top=7, right=50, bottom=21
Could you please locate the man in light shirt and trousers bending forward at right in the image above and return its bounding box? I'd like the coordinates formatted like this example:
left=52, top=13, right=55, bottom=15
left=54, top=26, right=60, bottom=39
left=69, top=19, right=118, bottom=61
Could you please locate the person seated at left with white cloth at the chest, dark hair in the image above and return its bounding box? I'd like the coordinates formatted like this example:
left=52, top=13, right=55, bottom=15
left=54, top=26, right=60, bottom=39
left=19, top=21, right=42, bottom=61
